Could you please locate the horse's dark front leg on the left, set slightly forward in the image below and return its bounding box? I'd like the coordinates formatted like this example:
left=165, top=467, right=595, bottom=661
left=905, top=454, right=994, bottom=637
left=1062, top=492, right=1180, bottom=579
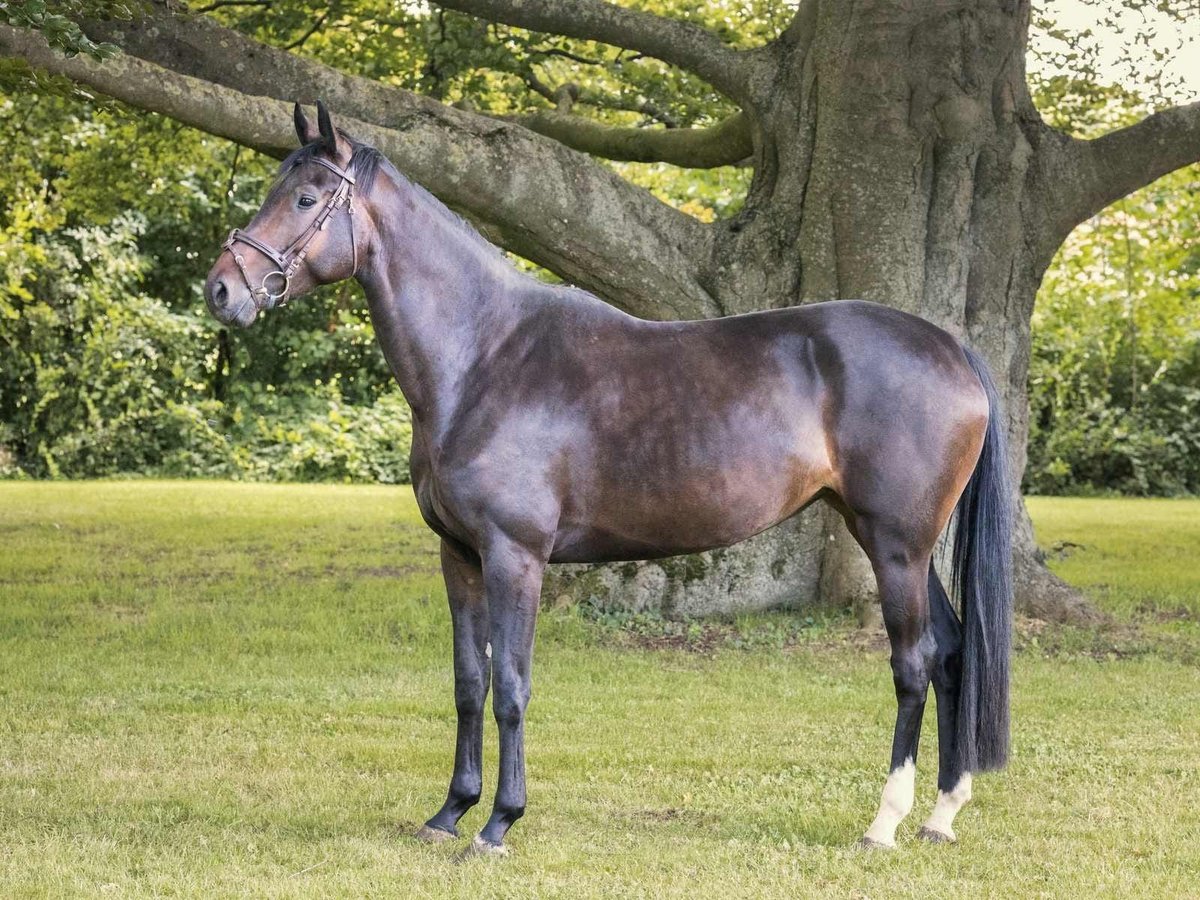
left=416, top=541, right=490, bottom=844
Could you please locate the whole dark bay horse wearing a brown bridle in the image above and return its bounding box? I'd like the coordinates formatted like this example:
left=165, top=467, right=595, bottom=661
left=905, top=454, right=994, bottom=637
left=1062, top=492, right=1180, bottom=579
left=205, top=106, right=1012, bottom=853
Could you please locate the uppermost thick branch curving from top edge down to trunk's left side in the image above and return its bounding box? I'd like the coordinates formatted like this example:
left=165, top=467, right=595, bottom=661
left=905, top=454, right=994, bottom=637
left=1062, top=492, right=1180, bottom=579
left=429, top=0, right=752, bottom=104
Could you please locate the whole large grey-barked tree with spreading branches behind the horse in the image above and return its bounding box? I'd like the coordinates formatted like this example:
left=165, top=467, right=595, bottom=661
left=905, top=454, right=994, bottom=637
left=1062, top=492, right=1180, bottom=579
left=0, top=0, right=1200, bottom=618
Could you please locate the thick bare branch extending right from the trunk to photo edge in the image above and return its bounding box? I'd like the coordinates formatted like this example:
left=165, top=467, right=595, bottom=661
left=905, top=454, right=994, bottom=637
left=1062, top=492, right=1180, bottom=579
left=1043, top=102, right=1200, bottom=246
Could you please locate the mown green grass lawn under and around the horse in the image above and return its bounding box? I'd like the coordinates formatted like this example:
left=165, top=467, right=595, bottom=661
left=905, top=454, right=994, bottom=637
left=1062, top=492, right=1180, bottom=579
left=0, top=482, right=1200, bottom=899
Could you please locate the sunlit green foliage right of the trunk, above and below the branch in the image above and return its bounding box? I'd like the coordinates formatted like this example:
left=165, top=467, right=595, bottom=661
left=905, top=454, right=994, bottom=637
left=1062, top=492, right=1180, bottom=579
left=1025, top=12, right=1200, bottom=494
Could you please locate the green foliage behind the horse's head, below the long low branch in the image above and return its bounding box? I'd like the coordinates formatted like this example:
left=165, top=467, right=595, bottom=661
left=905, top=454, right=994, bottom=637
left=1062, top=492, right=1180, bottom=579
left=0, top=95, right=409, bottom=482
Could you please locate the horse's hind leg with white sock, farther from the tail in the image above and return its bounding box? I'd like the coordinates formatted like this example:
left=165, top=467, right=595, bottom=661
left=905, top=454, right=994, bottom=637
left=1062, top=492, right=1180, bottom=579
left=853, top=520, right=934, bottom=848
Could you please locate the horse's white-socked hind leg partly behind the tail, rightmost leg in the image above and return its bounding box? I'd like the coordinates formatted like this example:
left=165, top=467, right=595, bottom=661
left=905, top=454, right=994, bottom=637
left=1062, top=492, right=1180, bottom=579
left=917, top=565, right=971, bottom=844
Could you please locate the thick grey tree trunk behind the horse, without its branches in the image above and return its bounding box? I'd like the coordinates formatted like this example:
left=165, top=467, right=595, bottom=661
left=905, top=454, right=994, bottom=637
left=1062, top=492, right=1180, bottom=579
left=556, top=0, right=1093, bottom=623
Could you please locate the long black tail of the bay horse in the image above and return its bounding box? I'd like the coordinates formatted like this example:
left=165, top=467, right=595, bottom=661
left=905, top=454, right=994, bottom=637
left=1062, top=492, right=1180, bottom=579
left=953, top=347, right=1013, bottom=772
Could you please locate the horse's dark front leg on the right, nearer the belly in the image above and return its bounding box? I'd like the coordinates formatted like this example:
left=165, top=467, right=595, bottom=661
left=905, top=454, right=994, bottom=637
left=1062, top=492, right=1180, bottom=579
left=467, top=540, right=546, bottom=856
